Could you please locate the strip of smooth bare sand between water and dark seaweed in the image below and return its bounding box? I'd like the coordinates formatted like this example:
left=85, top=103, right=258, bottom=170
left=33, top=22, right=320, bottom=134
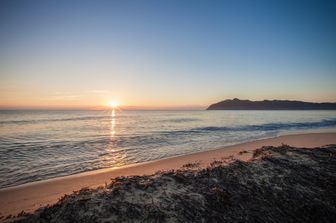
left=0, top=133, right=336, bottom=216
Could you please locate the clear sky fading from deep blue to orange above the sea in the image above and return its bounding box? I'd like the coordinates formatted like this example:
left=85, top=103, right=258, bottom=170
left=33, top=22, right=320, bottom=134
left=0, top=0, right=336, bottom=108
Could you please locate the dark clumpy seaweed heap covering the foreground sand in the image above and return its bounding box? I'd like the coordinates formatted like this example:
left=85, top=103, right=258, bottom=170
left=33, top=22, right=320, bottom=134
left=10, top=145, right=336, bottom=222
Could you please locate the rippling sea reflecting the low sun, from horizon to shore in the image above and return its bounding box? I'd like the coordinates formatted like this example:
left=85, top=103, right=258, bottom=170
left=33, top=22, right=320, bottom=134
left=0, top=111, right=336, bottom=188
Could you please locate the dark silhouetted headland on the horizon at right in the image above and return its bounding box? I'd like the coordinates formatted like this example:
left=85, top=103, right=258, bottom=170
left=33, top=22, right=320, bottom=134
left=207, top=98, right=336, bottom=110
